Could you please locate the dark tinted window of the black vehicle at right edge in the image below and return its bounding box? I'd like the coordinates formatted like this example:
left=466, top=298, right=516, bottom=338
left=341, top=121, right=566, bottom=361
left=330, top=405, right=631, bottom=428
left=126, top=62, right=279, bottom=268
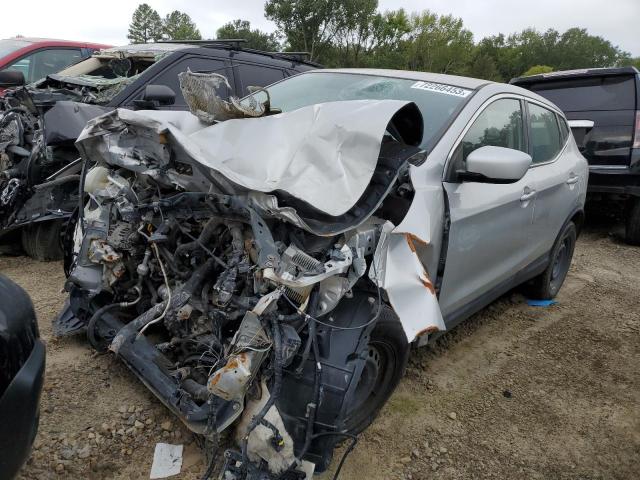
left=531, top=75, right=636, bottom=112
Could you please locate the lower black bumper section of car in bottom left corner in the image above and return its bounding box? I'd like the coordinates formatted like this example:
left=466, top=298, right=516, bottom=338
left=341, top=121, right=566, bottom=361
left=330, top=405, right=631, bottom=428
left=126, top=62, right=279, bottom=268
left=0, top=339, right=45, bottom=480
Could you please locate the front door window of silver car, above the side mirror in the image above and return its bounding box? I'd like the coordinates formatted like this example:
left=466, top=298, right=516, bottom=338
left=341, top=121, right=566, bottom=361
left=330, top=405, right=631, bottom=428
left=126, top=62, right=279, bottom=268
left=461, top=98, right=526, bottom=161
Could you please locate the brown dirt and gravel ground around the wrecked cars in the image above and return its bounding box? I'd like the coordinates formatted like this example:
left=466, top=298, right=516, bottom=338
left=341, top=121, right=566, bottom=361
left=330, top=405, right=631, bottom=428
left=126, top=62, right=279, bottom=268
left=0, top=214, right=640, bottom=480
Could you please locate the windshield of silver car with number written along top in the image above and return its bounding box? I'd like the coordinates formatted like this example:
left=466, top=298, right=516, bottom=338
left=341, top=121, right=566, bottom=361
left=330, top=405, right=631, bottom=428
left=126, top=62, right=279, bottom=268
left=258, top=72, right=471, bottom=148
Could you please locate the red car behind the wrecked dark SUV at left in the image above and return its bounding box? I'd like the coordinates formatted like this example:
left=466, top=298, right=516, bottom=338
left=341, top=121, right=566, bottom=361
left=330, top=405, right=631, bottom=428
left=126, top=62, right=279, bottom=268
left=0, top=37, right=110, bottom=93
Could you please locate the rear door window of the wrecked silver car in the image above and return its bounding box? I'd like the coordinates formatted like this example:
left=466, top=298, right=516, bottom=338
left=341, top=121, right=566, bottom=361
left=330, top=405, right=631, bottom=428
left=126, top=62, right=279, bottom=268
left=529, top=103, right=563, bottom=164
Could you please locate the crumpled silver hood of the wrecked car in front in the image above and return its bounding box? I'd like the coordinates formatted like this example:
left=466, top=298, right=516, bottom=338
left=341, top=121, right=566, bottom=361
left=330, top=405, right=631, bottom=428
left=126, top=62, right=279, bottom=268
left=77, top=100, right=422, bottom=216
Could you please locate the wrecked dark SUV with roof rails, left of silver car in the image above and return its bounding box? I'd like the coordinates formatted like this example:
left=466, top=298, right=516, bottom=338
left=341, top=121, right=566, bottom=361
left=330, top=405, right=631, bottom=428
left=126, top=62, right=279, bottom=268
left=0, top=40, right=319, bottom=260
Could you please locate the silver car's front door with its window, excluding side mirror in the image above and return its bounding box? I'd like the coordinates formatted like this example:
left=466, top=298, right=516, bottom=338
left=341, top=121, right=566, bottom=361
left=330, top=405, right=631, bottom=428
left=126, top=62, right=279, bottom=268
left=440, top=97, right=537, bottom=318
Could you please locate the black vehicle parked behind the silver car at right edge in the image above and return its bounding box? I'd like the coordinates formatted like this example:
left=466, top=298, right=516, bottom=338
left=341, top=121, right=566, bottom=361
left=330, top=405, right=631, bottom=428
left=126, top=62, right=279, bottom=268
left=511, top=67, right=640, bottom=245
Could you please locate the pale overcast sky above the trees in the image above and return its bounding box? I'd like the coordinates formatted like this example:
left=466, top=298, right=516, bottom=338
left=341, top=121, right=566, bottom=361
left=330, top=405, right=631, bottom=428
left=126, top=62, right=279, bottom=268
left=5, top=0, right=640, bottom=56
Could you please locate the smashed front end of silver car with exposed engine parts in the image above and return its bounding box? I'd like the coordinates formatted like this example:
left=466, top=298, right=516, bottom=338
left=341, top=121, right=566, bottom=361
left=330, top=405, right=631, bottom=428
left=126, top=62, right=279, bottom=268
left=56, top=99, right=430, bottom=479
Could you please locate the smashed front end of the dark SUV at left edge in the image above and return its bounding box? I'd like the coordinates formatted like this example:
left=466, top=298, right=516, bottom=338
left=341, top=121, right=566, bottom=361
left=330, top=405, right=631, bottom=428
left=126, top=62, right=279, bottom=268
left=0, top=87, right=107, bottom=235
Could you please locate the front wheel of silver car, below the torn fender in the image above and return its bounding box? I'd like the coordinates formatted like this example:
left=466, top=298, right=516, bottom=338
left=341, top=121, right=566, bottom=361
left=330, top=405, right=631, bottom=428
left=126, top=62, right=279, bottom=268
left=345, top=306, right=410, bottom=435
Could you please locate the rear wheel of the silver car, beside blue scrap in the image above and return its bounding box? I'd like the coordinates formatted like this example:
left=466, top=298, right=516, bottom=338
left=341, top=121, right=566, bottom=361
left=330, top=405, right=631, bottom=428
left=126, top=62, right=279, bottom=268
left=527, top=222, right=578, bottom=300
